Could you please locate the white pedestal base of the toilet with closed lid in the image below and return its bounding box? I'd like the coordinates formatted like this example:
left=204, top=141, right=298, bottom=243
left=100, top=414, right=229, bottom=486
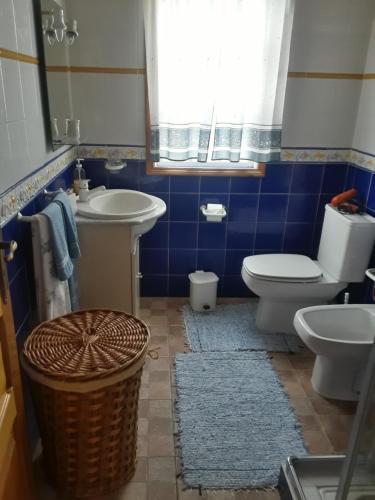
left=255, top=297, right=325, bottom=335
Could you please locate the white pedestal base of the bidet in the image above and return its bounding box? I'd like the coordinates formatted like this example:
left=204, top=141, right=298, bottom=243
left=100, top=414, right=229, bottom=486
left=311, top=355, right=366, bottom=401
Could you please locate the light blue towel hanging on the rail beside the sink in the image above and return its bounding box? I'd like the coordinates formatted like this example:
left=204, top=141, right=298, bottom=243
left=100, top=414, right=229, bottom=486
left=41, top=202, right=74, bottom=281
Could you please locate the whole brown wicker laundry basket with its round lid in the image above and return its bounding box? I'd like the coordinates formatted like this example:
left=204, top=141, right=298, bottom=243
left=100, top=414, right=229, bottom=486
left=23, top=310, right=149, bottom=498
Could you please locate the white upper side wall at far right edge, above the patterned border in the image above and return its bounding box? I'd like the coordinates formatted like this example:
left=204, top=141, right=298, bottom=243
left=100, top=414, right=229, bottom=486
left=353, top=20, right=375, bottom=154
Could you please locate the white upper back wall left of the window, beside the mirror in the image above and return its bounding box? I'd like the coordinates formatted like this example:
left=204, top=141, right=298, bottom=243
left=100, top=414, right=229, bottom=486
left=66, top=0, right=145, bottom=146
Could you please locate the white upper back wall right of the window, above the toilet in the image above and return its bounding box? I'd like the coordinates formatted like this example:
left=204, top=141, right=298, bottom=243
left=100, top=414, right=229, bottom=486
left=283, top=0, right=375, bottom=148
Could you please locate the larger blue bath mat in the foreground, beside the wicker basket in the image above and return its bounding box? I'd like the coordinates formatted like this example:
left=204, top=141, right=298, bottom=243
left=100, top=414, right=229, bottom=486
left=176, top=352, right=306, bottom=488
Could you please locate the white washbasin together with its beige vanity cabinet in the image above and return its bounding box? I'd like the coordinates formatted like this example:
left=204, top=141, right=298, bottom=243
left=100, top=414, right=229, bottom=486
left=76, top=189, right=166, bottom=315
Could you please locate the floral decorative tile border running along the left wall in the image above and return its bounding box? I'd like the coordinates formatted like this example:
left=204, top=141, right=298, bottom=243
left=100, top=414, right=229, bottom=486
left=0, top=147, right=77, bottom=227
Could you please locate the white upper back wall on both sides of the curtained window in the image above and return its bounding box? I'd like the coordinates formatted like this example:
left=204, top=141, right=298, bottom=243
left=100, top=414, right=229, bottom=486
left=61, top=0, right=375, bottom=148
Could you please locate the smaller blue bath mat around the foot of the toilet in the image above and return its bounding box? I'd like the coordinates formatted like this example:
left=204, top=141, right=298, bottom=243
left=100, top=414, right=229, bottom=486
left=182, top=301, right=303, bottom=352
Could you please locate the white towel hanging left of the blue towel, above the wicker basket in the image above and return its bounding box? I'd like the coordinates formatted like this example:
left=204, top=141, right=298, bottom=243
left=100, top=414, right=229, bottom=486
left=31, top=215, right=71, bottom=321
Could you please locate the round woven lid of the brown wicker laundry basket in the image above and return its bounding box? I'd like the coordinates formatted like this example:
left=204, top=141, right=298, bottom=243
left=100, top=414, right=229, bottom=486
left=23, top=309, right=150, bottom=380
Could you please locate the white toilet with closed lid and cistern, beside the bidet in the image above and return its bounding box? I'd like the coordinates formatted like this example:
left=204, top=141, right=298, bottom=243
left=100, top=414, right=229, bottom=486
left=241, top=205, right=375, bottom=334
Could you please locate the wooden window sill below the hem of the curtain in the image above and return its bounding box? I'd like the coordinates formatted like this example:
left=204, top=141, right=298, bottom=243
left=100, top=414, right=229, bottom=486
left=146, top=160, right=265, bottom=177
